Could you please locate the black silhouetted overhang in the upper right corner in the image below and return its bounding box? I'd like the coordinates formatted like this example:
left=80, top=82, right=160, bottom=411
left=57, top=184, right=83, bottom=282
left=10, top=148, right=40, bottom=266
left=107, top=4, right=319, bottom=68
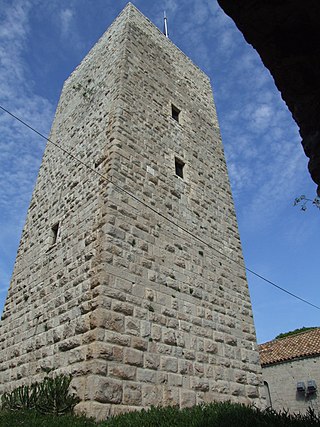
left=218, top=0, right=320, bottom=195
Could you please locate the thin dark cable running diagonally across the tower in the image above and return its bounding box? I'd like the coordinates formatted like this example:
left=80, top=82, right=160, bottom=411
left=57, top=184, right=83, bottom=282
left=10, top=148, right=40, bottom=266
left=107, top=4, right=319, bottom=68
left=0, top=104, right=320, bottom=310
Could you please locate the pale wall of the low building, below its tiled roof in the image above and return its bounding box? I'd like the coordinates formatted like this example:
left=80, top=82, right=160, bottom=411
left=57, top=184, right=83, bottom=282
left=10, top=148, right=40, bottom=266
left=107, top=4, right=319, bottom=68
left=262, top=356, right=320, bottom=413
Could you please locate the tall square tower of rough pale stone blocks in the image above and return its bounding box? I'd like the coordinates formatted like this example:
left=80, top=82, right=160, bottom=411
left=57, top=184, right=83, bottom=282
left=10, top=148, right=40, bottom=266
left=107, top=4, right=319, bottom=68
left=0, top=3, right=263, bottom=418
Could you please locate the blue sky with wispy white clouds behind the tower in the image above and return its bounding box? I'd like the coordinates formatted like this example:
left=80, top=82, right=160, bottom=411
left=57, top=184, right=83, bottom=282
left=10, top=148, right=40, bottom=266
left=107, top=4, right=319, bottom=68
left=0, top=0, right=320, bottom=342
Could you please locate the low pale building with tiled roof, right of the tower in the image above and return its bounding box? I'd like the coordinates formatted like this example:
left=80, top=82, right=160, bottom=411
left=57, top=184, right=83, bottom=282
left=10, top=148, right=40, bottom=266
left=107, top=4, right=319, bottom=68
left=259, top=328, right=320, bottom=413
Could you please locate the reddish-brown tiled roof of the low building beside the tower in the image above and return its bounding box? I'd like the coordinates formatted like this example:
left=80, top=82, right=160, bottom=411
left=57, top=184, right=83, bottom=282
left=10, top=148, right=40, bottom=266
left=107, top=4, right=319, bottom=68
left=259, top=328, right=320, bottom=366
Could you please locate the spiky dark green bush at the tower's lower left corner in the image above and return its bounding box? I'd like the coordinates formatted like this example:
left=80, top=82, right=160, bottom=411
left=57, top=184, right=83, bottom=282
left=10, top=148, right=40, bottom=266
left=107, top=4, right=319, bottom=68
left=1, top=374, right=80, bottom=415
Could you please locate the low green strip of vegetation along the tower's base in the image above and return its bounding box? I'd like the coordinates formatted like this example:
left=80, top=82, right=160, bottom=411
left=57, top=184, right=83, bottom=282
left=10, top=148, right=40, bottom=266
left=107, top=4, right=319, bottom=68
left=0, top=403, right=320, bottom=427
